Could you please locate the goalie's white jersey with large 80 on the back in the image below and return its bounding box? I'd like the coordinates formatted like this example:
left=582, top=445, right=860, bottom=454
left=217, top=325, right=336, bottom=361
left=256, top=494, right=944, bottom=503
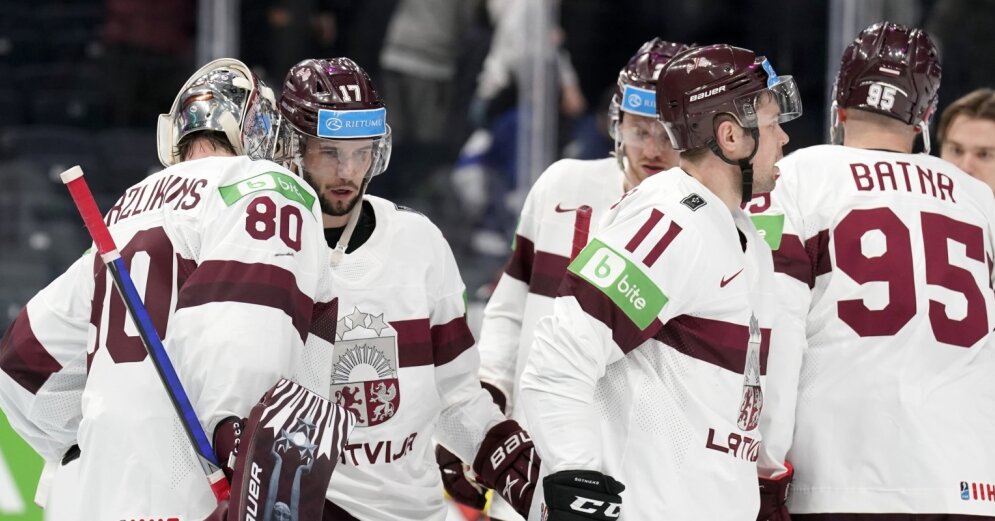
left=0, top=157, right=328, bottom=521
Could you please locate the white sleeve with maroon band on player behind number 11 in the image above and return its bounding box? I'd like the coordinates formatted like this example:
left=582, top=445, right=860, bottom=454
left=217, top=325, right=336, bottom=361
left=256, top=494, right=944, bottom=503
left=477, top=176, right=543, bottom=407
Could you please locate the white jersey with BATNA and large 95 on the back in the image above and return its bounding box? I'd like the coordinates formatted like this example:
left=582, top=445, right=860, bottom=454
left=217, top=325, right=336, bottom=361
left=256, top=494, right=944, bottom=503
left=762, top=145, right=995, bottom=519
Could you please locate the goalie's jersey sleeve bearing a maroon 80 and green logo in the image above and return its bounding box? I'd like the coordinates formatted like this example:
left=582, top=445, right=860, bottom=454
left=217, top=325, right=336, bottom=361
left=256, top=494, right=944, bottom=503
left=165, top=162, right=327, bottom=434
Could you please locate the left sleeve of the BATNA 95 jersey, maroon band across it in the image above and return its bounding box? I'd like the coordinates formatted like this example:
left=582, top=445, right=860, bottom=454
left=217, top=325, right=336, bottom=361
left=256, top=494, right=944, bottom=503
left=757, top=156, right=812, bottom=477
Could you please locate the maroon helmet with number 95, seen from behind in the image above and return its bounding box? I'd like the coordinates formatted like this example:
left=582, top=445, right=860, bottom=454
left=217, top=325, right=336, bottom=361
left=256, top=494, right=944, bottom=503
left=833, top=22, right=940, bottom=146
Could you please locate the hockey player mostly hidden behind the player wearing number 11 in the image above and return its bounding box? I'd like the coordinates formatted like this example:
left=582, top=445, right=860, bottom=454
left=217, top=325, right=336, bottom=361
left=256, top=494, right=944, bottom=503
left=464, top=38, right=688, bottom=521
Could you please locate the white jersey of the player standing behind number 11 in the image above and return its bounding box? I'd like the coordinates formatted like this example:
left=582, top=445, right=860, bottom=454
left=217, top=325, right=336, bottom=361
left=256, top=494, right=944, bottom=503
left=477, top=158, right=624, bottom=418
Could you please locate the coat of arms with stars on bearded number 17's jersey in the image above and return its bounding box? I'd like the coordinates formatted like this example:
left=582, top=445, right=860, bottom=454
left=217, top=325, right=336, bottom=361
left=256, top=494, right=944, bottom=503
left=331, top=307, right=401, bottom=427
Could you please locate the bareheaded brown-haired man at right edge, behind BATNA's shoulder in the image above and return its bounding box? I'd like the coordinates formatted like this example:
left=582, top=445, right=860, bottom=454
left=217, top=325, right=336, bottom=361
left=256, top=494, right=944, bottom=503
left=936, top=89, right=995, bottom=190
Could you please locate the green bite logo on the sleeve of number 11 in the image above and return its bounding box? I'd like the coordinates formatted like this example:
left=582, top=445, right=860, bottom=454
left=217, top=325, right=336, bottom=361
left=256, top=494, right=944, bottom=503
left=569, top=239, right=668, bottom=329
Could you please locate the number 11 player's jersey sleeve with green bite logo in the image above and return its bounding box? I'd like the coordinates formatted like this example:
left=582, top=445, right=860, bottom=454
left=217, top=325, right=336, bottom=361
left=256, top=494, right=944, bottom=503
left=521, top=204, right=702, bottom=472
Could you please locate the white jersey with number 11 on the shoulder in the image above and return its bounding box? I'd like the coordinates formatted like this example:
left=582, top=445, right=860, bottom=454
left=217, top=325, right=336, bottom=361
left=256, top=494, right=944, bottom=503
left=520, top=168, right=775, bottom=521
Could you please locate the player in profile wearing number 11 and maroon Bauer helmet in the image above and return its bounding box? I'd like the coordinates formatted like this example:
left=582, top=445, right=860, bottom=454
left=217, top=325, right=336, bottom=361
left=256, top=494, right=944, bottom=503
left=520, top=45, right=801, bottom=521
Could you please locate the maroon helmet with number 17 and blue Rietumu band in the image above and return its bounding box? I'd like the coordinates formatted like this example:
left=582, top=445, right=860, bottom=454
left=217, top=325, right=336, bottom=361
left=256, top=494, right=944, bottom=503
left=278, top=58, right=391, bottom=179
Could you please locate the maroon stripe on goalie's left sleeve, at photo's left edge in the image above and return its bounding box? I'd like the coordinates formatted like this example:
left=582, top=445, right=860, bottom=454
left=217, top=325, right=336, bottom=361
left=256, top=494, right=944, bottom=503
left=0, top=307, right=62, bottom=394
